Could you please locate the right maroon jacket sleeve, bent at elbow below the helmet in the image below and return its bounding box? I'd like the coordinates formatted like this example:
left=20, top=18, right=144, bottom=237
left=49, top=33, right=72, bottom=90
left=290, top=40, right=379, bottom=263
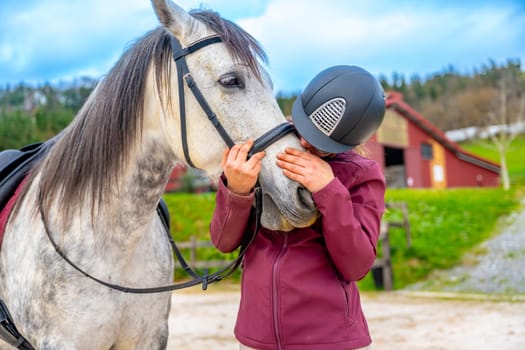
left=313, top=163, right=385, bottom=281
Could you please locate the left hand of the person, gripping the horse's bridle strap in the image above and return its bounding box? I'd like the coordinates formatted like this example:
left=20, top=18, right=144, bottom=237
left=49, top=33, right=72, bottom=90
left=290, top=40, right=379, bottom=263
left=221, top=139, right=265, bottom=195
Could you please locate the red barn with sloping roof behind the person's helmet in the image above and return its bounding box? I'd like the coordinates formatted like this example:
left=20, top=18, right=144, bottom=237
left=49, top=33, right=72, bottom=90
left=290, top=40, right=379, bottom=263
left=366, top=92, right=500, bottom=188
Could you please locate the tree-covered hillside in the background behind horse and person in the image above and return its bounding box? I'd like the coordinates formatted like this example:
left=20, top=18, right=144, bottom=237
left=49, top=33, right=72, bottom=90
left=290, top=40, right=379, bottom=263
left=0, top=59, right=525, bottom=150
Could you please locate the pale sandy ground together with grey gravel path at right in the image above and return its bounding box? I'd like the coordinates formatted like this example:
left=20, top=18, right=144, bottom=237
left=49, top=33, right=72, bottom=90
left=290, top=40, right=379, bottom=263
left=168, top=202, right=525, bottom=350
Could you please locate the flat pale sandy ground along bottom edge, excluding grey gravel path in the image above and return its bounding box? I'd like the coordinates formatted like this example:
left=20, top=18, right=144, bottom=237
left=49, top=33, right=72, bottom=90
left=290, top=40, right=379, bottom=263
left=168, top=286, right=525, bottom=350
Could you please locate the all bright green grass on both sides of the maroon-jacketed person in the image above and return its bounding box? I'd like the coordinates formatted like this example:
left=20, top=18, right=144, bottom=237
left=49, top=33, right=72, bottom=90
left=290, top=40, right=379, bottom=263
left=164, top=137, right=525, bottom=290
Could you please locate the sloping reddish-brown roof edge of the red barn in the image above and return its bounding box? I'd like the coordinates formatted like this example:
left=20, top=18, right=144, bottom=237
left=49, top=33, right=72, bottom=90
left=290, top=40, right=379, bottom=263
left=386, top=91, right=500, bottom=173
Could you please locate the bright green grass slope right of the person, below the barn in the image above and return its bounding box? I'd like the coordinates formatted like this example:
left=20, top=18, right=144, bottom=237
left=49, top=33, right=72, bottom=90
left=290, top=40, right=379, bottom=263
left=360, top=188, right=518, bottom=290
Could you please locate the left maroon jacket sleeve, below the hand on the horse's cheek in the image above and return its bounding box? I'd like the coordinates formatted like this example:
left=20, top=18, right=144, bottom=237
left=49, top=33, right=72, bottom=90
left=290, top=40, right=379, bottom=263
left=210, top=178, right=254, bottom=253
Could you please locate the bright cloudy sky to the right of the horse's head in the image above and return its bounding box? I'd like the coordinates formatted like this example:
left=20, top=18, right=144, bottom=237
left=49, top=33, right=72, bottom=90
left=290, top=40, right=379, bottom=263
left=239, top=0, right=525, bottom=88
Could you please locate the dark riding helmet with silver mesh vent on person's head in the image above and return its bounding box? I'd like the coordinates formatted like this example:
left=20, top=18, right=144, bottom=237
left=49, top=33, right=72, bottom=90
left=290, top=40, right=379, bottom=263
left=292, top=66, right=385, bottom=153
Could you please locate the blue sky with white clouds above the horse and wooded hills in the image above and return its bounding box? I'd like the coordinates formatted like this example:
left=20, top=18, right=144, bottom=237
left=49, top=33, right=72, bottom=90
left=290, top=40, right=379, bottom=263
left=0, top=0, right=525, bottom=94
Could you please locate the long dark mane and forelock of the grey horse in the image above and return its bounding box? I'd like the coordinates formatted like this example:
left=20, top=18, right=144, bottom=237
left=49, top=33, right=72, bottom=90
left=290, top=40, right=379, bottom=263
left=24, top=10, right=266, bottom=221
